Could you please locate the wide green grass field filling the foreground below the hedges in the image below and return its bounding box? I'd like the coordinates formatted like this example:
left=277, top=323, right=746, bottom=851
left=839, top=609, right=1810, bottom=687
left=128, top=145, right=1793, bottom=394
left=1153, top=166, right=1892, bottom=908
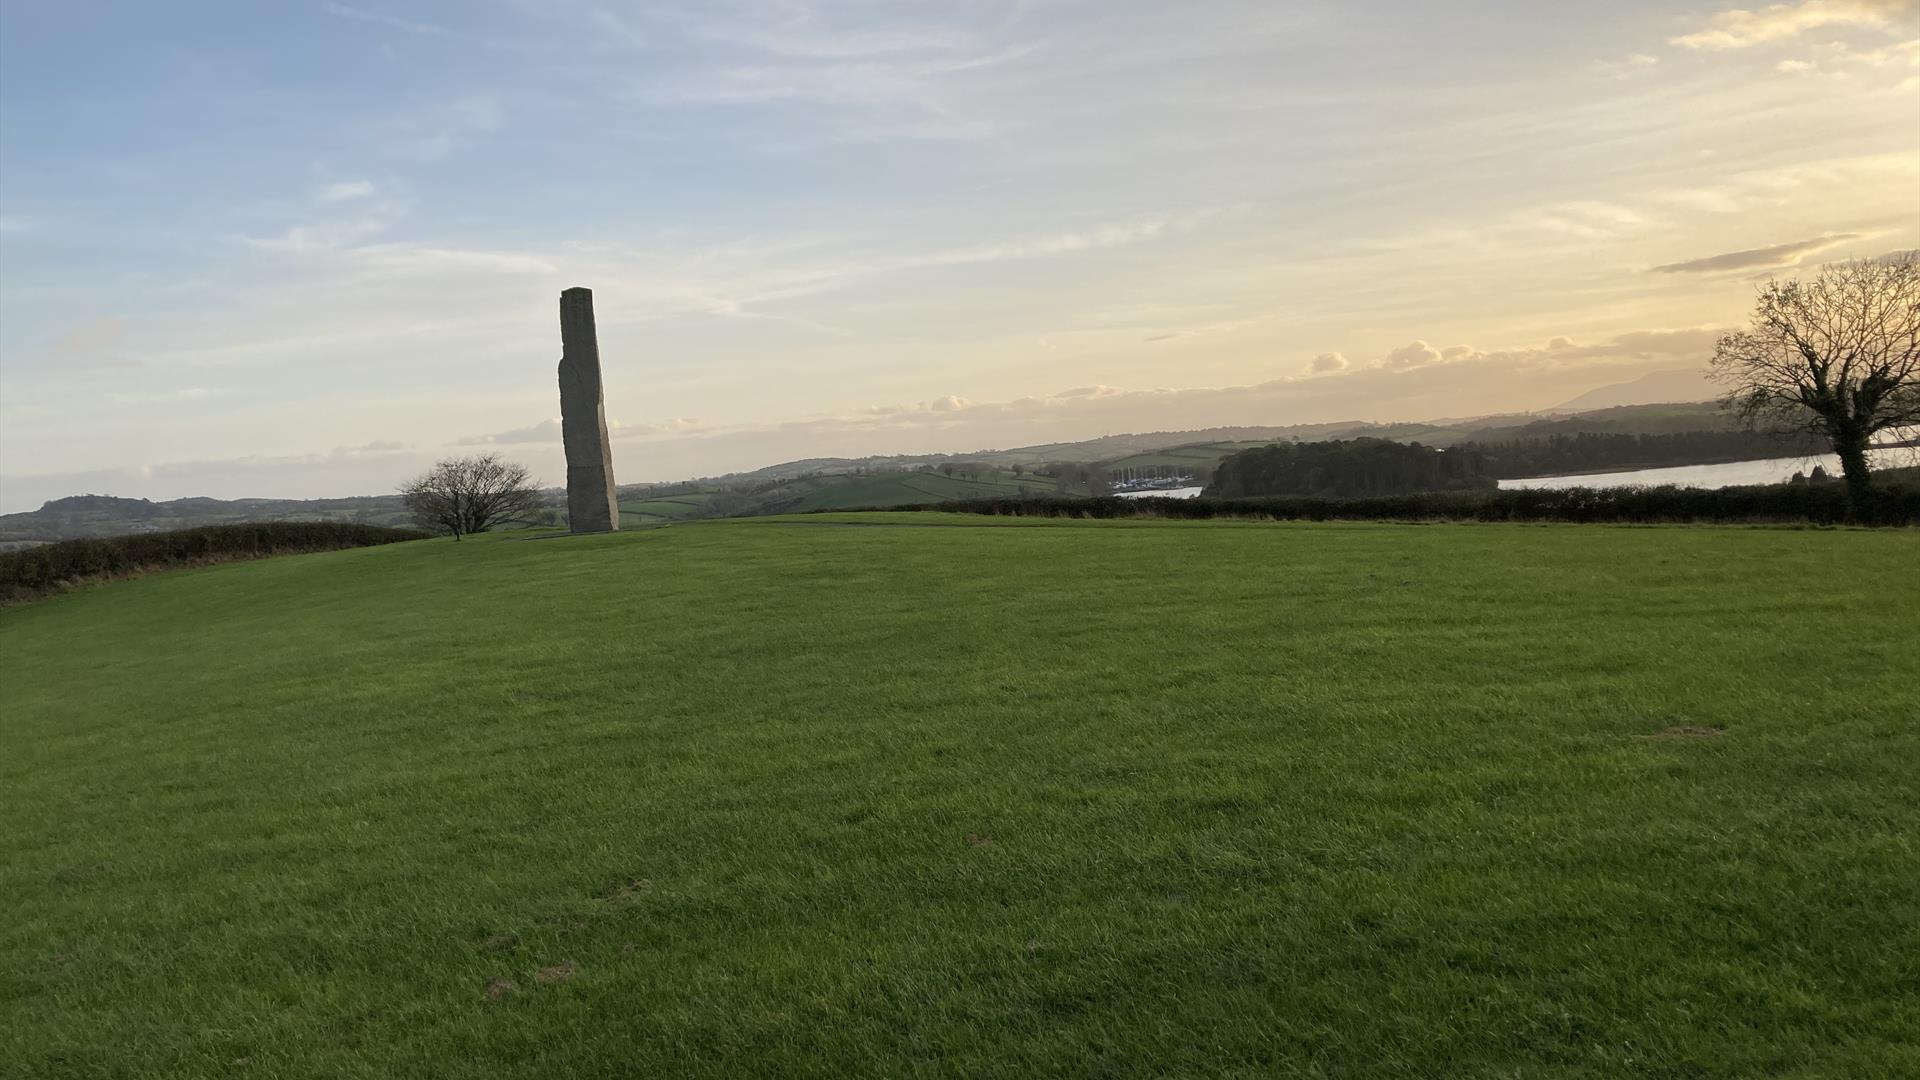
left=0, top=513, right=1920, bottom=1080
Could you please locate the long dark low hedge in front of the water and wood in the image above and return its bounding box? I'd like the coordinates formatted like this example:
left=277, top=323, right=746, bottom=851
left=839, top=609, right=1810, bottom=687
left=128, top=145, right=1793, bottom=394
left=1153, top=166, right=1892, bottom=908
left=922, top=484, right=1920, bottom=525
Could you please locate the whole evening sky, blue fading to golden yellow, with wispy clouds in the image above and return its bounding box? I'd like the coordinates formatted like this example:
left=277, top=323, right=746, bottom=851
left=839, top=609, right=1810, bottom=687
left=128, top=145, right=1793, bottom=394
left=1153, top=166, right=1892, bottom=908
left=0, top=0, right=1920, bottom=511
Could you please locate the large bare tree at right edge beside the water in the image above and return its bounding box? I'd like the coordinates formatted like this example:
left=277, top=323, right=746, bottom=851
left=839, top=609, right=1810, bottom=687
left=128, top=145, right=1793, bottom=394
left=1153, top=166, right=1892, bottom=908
left=1713, top=252, right=1920, bottom=502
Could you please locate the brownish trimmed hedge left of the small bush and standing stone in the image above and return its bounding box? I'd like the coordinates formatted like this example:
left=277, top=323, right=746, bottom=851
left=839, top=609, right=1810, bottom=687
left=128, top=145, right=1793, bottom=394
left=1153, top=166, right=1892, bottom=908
left=0, top=521, right=426, bottom=603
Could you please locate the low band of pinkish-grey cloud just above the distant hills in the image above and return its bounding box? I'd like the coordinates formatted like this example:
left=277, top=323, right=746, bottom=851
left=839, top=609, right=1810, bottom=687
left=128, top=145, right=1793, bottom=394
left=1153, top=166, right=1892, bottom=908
left=0, top=327, right=1718, bottom=513
